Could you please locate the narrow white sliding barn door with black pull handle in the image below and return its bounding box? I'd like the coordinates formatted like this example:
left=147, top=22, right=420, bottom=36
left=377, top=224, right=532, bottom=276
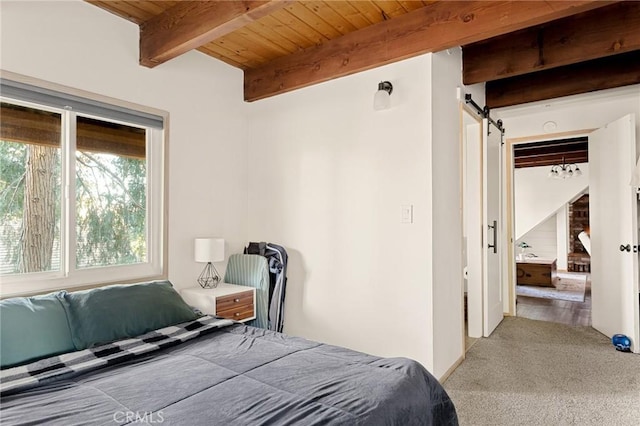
left=482, top=119, right=504, bottom=337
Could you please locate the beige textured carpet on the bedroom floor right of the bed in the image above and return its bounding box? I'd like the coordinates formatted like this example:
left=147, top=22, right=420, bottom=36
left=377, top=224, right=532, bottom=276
left=444, top=317, right=640, bottom=426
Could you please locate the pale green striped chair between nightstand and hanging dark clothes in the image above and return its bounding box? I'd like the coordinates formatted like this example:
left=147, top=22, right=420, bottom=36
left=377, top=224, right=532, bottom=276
left=224, top=254, right=269, bottom=329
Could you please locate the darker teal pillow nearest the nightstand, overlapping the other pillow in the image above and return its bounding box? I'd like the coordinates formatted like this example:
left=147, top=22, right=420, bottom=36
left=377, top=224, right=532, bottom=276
left=58, top=281, right=198, bottom=350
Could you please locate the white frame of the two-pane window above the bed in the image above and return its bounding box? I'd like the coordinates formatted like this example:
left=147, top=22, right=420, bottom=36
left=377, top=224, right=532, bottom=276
left=0, top=80, right=168, bottom=298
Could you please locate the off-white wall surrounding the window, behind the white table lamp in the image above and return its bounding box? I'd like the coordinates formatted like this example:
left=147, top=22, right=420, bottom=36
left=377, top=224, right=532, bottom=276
left=0, top=1, right=247, bottom=287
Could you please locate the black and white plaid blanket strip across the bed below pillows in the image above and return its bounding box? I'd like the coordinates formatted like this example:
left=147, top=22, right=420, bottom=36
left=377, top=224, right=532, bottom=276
left=0, top=316, right=235, bottom=395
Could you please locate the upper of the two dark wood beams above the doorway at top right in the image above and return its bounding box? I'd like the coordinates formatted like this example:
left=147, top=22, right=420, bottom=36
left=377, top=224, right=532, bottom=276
left=462, top=2, right=640, bottom=84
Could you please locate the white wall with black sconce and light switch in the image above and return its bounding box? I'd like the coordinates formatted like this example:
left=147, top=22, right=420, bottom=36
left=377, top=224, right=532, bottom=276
left=249, top=48, right=470, bottom=376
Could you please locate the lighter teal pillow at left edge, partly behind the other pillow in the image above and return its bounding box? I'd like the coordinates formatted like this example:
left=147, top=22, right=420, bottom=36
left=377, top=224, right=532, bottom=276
left=0, top=293, right=76, bottom=368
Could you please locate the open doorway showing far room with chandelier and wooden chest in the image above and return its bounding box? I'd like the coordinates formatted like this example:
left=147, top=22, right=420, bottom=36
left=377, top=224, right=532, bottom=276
left=509, top=136, right=591, bottom=325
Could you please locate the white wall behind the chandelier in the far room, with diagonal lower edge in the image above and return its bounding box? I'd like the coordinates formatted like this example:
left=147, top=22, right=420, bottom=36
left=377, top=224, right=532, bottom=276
left=513, top=163, right=589, bottom=240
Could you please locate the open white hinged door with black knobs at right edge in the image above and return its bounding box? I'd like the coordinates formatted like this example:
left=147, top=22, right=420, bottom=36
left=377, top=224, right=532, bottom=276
left=589, top=115, right=640, bottom=353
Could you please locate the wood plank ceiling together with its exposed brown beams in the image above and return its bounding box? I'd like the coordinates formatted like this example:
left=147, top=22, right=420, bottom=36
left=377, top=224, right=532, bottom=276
left=87, top=0, right=640, bottom=107
